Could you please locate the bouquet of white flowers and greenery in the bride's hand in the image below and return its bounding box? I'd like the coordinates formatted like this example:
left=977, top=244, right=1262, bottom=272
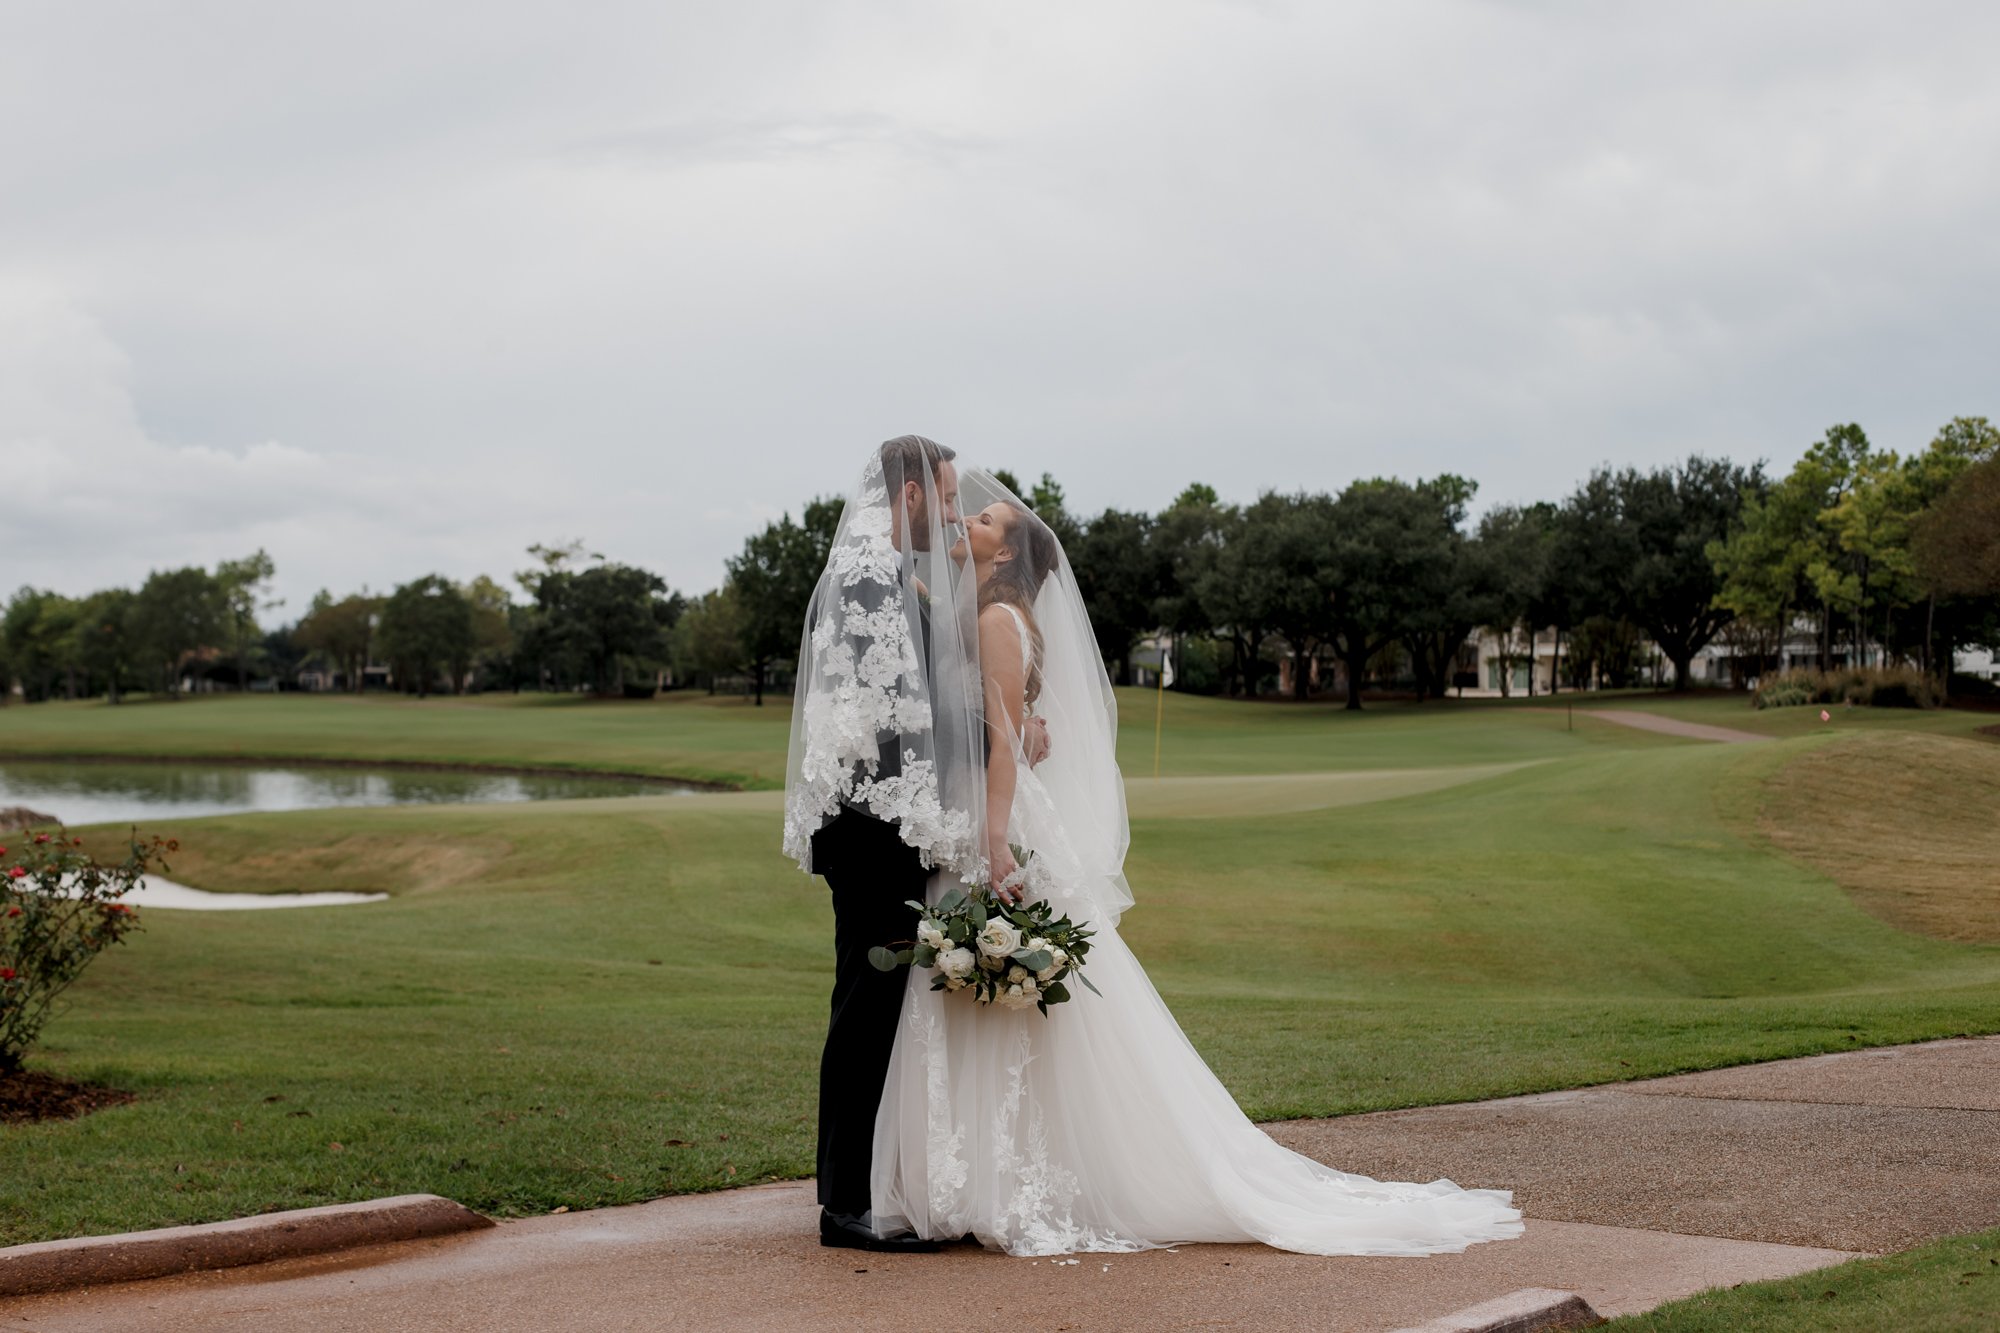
left=868, top=853, right=1096, bottom=1015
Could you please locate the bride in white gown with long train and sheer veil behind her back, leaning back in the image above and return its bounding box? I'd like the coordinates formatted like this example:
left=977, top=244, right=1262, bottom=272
left=870, top=468, right=1522, bottom=1255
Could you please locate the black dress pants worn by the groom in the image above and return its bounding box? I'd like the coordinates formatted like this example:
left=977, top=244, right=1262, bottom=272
left=812, top=811, right=932, bottom=1215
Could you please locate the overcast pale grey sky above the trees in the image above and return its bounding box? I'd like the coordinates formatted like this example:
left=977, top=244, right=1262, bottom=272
left=0, top=0, right=2000, bottom=618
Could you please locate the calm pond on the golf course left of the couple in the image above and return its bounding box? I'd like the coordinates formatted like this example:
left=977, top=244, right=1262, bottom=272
left=0, top=759, right=698, bottom=825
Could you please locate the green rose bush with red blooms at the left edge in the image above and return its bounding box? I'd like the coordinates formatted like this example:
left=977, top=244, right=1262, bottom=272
left=0, top=831, right=180, bottom=1073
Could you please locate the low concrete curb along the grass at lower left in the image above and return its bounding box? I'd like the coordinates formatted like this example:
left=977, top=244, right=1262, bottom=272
left=0, top=1195, right=496, bottom=1299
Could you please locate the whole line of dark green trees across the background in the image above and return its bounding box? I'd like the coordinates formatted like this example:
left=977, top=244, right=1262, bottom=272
left=0, top=418, right=2000, bottom=707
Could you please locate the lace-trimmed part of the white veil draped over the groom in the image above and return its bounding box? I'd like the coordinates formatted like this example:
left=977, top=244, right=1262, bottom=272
left=784, top=434, right=986, bottom=883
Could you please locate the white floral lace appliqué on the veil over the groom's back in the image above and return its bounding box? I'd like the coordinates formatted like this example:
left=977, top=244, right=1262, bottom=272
left=784, top=462, right=974, bottom=873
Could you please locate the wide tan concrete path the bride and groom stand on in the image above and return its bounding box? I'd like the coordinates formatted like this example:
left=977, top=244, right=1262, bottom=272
left=0, top=1037, right=2000, bottom=1333
